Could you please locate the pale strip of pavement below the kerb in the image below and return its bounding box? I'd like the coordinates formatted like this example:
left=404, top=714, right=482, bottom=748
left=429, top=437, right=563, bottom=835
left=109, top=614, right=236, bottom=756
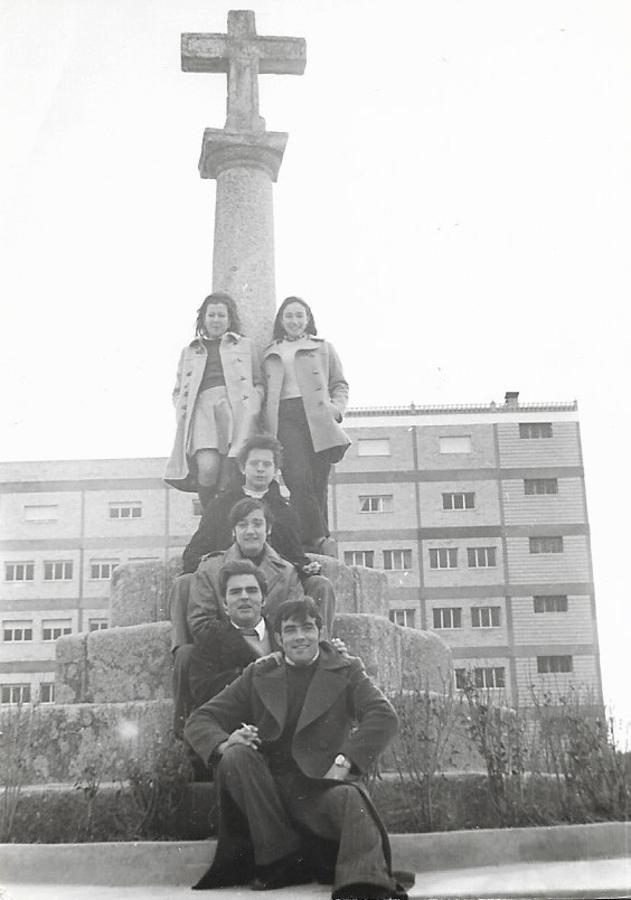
left=0, top=858, right=631, bottom=900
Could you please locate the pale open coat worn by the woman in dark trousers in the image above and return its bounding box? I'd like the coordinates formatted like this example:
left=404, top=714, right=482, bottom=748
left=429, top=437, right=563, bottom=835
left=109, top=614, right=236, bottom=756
left=263, top=336, right=350, bottom=459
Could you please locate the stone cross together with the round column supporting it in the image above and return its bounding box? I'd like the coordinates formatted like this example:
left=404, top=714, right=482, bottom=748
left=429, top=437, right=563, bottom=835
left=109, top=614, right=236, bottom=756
left=181, top=10, right=306, bottom=346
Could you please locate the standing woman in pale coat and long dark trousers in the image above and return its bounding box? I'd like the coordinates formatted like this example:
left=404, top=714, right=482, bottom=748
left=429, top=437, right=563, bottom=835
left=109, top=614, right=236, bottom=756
left=263, top=297, right=350, bottom=556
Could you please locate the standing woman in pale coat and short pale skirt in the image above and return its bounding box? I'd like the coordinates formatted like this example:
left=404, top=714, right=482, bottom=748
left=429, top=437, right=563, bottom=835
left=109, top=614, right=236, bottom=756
left=164, top=293, right=263, bottom=507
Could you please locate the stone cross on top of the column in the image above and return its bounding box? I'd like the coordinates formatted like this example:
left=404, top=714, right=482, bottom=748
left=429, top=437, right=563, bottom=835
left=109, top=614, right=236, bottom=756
left=182, top=9, right=306, bottom=132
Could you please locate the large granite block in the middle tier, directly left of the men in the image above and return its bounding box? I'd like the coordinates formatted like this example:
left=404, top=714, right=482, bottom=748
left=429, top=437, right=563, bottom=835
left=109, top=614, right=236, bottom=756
left=87, top=622, right=172, bottom=703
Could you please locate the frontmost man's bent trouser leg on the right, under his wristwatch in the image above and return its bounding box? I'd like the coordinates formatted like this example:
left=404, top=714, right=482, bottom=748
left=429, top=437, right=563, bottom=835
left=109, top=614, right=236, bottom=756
left=279, top=780, right=394, bottom=889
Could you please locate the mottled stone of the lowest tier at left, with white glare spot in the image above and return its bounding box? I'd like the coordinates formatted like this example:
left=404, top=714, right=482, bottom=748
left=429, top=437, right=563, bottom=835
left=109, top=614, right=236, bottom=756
left=0, top=700, right=173, bottom=784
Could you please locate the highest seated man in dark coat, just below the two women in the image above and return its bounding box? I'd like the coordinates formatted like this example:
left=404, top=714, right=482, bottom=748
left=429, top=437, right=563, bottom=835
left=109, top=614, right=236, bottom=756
left=182, top=434, right=321, bottom=580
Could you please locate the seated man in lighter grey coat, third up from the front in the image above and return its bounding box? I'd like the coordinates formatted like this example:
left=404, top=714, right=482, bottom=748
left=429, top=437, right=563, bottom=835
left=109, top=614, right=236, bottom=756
left=169, top=498, right=335, bottom=735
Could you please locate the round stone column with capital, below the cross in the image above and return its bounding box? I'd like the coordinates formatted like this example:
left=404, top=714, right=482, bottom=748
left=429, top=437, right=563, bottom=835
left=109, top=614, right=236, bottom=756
left=199, top=128, right=287, bottom=347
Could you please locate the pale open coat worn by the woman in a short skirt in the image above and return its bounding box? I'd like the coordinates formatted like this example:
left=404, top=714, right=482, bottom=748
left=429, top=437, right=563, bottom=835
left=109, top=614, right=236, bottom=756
left=164, top=331, right=264, bottom=491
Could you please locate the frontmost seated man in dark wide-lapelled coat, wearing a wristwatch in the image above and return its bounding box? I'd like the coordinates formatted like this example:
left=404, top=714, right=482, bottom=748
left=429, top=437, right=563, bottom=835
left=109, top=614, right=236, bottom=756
left=184, top=597, right=407, bottom=900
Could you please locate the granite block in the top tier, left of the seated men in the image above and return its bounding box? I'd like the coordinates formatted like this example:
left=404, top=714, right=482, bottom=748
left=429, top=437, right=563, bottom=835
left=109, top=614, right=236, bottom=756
left=110, top=557, right=182, bottom=627
